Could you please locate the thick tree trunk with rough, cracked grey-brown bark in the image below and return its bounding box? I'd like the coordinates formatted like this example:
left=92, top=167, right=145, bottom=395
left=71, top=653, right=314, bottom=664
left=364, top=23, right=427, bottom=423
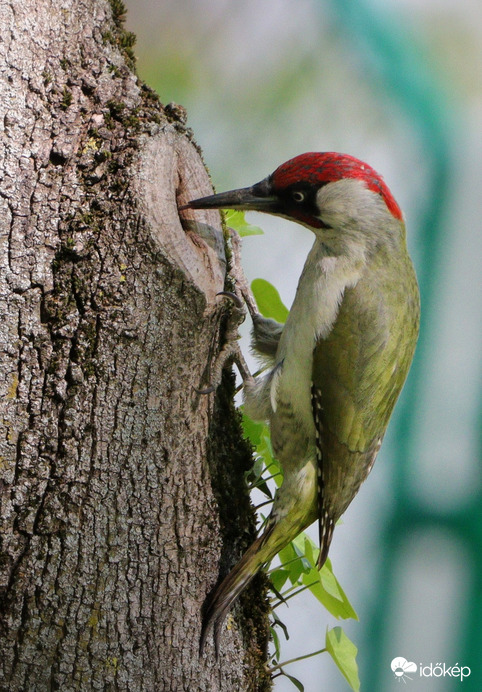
left=0, top=0, right=269, bottom=692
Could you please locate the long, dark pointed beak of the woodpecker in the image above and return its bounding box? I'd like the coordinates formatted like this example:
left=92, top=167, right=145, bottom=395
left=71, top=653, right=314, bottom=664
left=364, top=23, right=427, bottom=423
left=180, top=178, right=278, bottom=213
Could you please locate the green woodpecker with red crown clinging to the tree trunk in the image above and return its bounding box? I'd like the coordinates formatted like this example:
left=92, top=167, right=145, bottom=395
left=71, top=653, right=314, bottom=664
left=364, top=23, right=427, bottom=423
left=183, top=152, right=420, bottom=647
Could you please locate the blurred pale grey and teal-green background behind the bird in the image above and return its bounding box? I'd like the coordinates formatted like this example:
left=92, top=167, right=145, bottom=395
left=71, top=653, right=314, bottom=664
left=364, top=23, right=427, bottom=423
left=126, top=0, right=482, bottom=692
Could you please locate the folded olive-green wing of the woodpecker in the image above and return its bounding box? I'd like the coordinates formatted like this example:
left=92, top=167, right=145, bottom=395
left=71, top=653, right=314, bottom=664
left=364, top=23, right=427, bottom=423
left=312, top=241, right=419, bottom=563
